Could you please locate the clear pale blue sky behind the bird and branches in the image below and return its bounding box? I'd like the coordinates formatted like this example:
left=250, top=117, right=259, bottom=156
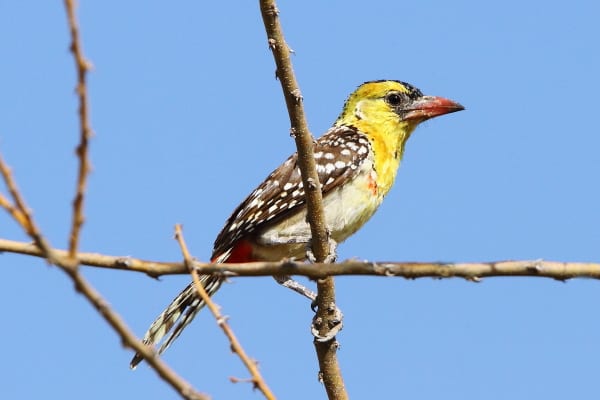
left=0, top=0, right=600, bottom=400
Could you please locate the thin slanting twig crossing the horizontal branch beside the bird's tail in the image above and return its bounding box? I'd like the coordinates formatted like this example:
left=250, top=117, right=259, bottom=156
left=175, top=224, right=275, bottom=400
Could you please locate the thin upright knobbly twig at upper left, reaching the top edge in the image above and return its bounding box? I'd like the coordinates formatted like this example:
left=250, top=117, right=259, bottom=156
left=65, top=0, right=92, bottom=258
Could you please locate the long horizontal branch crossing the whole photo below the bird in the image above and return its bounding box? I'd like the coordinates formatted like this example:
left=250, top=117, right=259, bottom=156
left=0, top=239, right=600, bottom=281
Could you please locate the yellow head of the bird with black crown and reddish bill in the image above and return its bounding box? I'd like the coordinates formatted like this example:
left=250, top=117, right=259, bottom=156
left=335, top=80, right=464, bottom=135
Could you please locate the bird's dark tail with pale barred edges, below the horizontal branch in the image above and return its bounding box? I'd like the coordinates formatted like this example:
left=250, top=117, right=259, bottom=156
left=129, top=275, right=222, bottom=369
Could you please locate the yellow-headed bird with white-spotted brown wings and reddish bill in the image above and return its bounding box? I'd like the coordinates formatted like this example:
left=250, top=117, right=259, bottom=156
left=130, top=80, right=464, bottom=369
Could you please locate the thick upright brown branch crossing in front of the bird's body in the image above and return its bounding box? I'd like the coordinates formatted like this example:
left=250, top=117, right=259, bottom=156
left=260, top=0, right=348, bottom=399
